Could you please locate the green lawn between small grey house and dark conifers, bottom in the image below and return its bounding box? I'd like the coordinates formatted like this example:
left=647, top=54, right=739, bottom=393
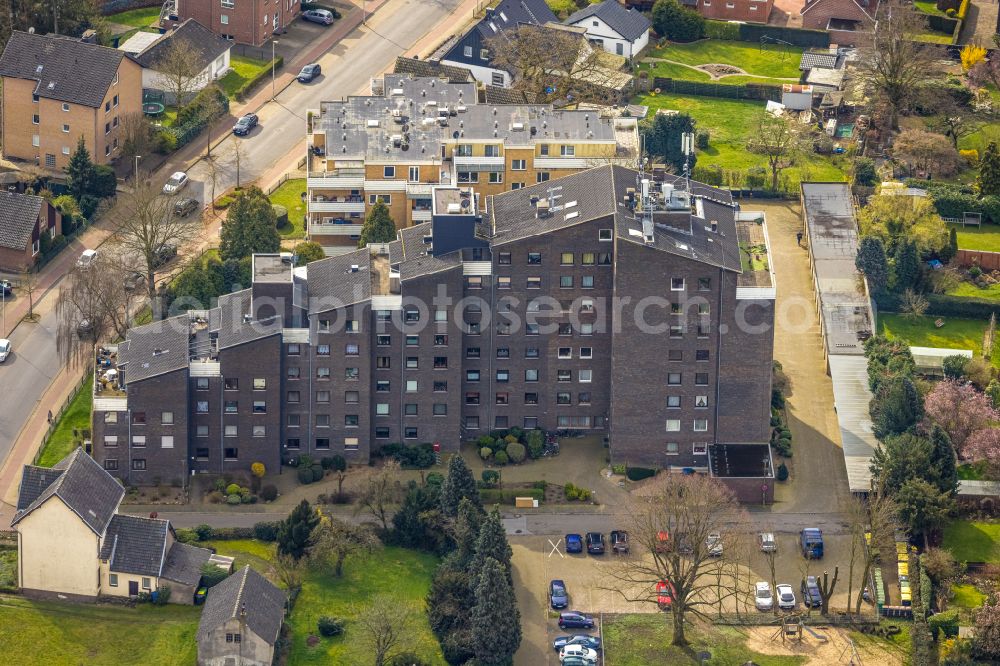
left=208, top=540, right=445, bottom=666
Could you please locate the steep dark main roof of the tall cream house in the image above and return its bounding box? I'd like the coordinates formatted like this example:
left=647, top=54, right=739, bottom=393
left=11, top=448, right=125, bottom=534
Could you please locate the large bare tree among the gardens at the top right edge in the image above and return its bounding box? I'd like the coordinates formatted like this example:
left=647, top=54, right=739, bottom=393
left=859, top=0, right=934, bottom=129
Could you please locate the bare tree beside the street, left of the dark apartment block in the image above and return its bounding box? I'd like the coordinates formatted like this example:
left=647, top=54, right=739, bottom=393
left=112, top=176, right=201, bottom=304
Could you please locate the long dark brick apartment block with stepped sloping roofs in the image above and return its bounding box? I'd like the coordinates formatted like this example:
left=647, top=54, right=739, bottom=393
left=94, top=165, right=774, bottom=501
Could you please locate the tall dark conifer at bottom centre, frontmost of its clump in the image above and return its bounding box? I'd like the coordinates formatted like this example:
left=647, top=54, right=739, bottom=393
left=470, top=558, right=521, bottom=666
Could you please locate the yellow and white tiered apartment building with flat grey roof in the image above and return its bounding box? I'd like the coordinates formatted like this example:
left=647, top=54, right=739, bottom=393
left=307, top=74, right=639, bottom=255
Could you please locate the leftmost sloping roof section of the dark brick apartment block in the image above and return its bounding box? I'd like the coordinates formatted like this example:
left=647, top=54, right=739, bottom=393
left=118, top=314, right=190, bottom=383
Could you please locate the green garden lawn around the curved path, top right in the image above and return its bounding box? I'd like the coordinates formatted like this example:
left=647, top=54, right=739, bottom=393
left=649, top=39, right=805, bottom=83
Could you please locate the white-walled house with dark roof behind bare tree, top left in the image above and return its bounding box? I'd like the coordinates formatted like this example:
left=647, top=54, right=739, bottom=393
left=118, top=19, right=233, bottom=104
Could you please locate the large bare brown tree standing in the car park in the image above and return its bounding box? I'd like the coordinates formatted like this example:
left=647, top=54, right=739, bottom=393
left=605, top=474, right=746, bottom=646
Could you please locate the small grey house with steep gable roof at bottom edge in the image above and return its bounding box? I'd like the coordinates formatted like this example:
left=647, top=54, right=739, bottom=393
left=198, top=564, right=288, bottom=666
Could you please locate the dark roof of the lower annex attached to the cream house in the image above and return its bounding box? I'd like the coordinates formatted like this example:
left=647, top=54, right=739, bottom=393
left=101, top=513, right=170, bottom=576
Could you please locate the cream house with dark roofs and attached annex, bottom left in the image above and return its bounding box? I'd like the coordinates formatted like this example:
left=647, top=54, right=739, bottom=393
left=11, top=448, right=211, bottom=604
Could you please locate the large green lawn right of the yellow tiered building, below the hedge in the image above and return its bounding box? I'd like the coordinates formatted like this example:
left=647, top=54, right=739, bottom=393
left=632, top=93, right=849, bottom=189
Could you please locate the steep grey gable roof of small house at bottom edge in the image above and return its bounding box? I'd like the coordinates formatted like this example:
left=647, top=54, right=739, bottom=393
left=198, top=565, right=287, bottom=645
